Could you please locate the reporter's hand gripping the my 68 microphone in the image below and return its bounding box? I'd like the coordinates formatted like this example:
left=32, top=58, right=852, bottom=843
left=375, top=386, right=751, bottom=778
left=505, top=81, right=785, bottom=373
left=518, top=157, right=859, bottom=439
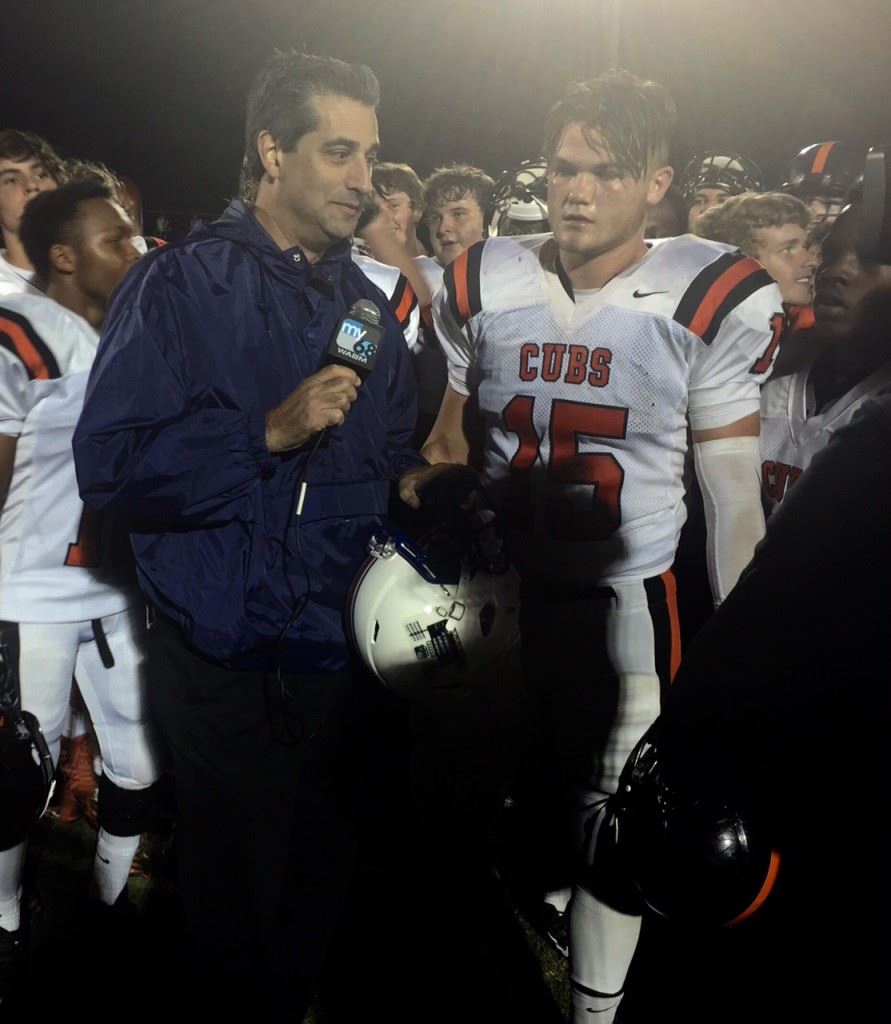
left=266, top=366, right=362, bottom=452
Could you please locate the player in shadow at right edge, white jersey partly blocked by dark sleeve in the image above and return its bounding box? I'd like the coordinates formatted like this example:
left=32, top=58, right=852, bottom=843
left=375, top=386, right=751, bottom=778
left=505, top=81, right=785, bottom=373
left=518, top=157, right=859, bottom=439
left=761, top=194, right=891, bottom=512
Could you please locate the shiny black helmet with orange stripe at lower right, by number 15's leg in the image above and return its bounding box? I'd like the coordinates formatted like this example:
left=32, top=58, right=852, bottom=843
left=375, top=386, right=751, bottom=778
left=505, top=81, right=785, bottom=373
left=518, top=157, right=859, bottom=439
left=614, top=730, right=779, bottom=927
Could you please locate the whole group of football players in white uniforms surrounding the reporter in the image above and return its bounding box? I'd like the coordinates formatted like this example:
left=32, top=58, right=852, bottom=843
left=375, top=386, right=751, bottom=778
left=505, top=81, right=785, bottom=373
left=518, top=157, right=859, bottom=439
left=0, top=51, right=891, bottom=1022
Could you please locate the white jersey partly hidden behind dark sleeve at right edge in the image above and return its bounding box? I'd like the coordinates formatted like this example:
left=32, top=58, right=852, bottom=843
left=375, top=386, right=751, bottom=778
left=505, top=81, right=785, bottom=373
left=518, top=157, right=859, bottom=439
left=759, top=364, right=891, bottom=513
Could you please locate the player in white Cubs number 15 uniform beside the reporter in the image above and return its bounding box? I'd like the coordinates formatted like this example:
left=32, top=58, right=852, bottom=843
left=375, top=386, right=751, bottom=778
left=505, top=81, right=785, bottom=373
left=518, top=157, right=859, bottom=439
left=400, top=72, right=782, bottom=1022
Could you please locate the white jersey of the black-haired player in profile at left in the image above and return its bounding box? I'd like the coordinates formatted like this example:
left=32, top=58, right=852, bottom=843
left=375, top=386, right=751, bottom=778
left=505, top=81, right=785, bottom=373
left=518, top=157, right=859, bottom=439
left=0, top=295, right=133, bottom=623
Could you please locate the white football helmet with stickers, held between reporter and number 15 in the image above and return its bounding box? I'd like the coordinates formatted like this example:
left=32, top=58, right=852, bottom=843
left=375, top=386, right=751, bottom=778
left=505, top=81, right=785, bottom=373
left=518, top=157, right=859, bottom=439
left=347, top=520, right=519, bottom=700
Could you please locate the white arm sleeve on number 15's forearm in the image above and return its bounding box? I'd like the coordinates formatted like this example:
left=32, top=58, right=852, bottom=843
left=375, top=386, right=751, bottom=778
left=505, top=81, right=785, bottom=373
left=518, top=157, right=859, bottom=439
left=693, top=436, right=764, bottom=606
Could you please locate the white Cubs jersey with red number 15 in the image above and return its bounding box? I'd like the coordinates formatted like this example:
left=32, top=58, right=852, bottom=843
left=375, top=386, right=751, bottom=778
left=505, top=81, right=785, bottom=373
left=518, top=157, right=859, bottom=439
left=434, top=234, right=783, bottom=587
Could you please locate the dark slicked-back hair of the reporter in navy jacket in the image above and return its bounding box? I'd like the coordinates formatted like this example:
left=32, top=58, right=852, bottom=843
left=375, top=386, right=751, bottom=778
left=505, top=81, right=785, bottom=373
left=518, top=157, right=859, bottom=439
left=242, top=52, right=380, bottom=195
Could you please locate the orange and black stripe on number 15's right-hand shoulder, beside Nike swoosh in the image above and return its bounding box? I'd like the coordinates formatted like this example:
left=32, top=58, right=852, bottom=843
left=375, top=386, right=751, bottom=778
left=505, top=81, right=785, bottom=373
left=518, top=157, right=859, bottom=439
left=674, top=252, right=773, bottom=345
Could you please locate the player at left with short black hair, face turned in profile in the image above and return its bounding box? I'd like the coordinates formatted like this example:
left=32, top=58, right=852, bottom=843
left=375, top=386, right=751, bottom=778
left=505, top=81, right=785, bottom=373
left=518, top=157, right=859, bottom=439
left=0, top=182, right=151, bottom=997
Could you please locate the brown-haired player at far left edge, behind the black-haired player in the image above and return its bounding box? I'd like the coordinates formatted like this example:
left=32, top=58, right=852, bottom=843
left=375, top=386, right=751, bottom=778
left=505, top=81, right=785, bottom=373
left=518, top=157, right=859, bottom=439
left=0, top=128, right=65, bottom=296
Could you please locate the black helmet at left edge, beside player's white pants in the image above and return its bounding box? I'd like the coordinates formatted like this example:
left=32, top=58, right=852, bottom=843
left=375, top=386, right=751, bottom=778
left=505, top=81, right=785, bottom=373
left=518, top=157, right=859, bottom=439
left=0, top=639, right=53, bottom=850
